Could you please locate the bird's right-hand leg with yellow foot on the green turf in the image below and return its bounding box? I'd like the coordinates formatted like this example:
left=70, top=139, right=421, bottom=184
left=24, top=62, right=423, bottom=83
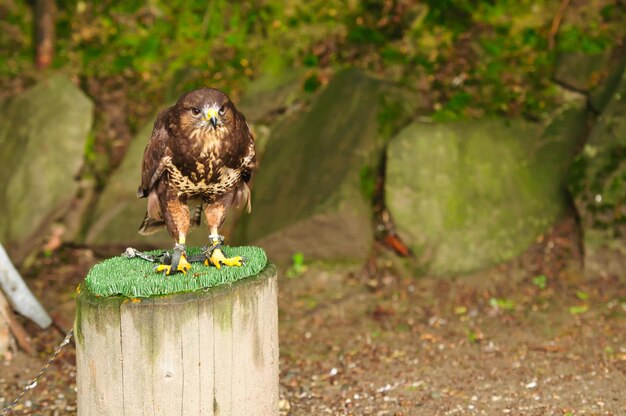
left=204, top=199, right=244, bottom=269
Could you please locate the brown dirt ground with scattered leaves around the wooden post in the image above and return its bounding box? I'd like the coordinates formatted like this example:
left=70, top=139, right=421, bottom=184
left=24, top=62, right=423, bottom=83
left=0, top=216, right=626, bottom=415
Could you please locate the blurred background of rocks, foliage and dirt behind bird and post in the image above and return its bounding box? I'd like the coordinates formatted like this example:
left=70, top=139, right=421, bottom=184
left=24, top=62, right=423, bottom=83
left=0, top=0, right=626, bottom=415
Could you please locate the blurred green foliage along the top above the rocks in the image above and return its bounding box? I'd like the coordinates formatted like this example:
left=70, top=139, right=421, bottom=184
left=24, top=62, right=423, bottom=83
left=0, top=0, right=625, bottom=124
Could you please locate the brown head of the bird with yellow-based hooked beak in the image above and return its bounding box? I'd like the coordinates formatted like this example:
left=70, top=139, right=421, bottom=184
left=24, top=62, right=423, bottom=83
left=176, top=88, right=235, bottom=138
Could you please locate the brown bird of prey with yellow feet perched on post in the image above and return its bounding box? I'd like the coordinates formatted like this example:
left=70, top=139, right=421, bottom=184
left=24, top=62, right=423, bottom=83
left=137, top=88, right=256, bottom=274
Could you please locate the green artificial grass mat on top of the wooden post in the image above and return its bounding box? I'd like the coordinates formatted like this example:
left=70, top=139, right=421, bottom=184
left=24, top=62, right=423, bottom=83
left=85, top=246, right=267, bottom=298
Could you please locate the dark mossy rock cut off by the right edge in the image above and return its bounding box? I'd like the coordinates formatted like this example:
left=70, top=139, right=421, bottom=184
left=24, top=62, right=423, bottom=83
left=571, top=67, right=626, bottom=276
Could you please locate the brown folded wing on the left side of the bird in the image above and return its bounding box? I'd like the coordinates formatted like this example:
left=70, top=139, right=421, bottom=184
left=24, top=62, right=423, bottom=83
left=137, top=108, right=171, bottom=198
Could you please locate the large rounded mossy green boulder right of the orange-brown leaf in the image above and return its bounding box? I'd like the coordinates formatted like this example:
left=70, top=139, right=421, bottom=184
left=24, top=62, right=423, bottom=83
left=385, top=108, right=586, bottom=275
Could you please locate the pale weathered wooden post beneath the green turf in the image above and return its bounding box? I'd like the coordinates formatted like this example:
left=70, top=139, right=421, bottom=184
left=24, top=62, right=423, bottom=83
left=75, top=264, right=278, bottom=416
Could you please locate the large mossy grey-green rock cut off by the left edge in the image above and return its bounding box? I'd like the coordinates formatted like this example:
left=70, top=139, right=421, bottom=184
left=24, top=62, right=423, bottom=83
left=0, top=76, right=93, bottom=262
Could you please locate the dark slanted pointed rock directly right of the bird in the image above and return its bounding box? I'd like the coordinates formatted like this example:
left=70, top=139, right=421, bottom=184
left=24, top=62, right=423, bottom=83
left=238, top=69, right=382, bottom=262
